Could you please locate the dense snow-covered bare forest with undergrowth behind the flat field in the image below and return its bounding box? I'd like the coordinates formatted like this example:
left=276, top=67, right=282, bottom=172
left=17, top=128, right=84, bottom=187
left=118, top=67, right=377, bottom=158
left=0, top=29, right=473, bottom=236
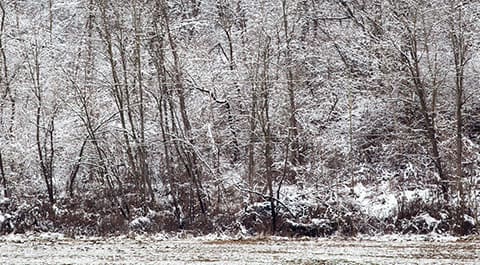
left=0, top=0, right=480, bottom=236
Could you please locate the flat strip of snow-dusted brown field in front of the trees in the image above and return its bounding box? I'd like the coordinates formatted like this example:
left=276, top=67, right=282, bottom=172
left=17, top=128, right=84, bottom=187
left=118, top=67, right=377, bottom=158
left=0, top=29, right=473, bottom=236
left=0, top=234, right=480, bottom=265
